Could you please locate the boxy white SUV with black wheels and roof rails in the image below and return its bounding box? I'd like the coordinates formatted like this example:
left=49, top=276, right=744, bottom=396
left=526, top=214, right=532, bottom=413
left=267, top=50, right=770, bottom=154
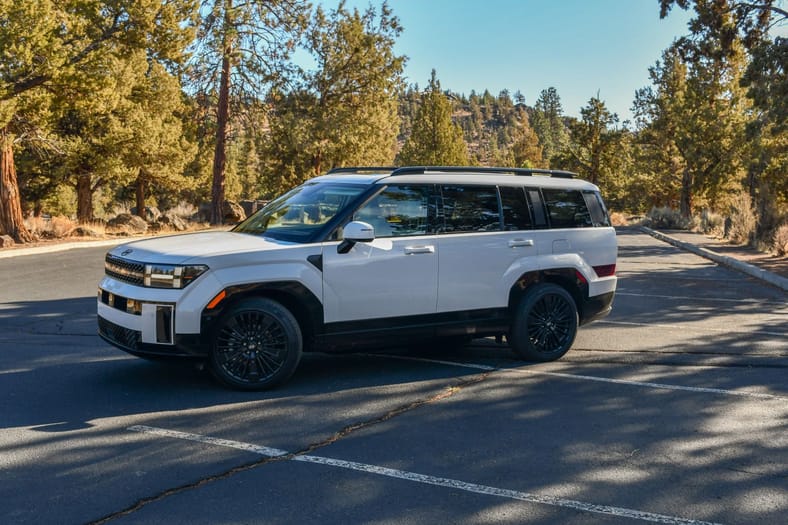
left=98, top=167, right=617, bottom=390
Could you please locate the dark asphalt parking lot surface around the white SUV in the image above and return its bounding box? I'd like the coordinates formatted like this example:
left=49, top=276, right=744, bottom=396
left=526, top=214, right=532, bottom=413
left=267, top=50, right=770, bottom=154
left=0, top=230, right=788, bottom=524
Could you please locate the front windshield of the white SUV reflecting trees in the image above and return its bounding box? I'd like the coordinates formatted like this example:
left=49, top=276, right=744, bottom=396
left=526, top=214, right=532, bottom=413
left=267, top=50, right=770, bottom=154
left=233, top=182, right=369, bottom=242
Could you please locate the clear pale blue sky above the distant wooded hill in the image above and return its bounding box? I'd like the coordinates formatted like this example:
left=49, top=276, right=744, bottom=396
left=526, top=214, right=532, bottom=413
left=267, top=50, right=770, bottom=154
left=321, top=0, right=690, bottom=121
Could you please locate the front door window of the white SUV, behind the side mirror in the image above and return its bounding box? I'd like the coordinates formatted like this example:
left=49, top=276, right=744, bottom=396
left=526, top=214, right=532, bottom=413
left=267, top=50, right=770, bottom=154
left=353, top=182, right=434, bottom=237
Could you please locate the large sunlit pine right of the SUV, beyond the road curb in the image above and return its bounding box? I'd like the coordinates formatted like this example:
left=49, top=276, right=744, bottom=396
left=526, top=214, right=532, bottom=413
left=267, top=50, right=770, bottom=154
left=638, top=37, right=749, bottom=217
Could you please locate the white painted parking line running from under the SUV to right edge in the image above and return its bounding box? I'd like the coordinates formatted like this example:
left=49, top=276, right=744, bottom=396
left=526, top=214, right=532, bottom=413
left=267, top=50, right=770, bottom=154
left=374, top=354, right=788, bottom=401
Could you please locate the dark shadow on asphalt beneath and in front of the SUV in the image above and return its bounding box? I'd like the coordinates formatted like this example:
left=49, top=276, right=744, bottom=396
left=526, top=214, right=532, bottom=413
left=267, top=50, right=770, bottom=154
left=0, top=297, right=492, bottom=433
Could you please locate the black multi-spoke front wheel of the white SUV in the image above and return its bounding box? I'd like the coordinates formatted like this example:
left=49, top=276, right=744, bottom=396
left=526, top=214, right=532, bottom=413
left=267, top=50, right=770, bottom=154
left=210, top=298, right=302, bottom=390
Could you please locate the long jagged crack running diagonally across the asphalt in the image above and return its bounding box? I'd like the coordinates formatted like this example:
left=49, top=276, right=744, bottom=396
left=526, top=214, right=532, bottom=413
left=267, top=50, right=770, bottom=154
left=87, top=370, right=493, bottom=525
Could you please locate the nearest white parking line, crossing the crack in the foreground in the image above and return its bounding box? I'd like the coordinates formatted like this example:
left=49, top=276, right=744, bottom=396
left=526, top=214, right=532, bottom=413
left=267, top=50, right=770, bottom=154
left=127, top=425, right=717, bottom=525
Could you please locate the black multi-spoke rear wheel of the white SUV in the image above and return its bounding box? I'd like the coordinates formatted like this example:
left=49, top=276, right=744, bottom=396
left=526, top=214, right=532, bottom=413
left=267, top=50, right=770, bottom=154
left=508, top=283, right=578, bottom=362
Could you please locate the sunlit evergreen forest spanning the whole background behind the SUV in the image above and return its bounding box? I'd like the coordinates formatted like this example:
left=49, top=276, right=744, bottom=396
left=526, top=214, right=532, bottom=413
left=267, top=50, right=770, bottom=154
left=0, top=0, right=788, bottom=250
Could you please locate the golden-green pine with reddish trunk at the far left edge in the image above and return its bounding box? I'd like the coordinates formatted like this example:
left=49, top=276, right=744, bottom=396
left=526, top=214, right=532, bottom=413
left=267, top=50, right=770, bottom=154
left=0, top=0, right=196, bottom=242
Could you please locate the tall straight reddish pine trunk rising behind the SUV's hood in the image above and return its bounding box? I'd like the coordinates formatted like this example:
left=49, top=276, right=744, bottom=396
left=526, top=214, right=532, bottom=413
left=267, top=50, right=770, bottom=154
left=210, top=0, right=233, bottom=224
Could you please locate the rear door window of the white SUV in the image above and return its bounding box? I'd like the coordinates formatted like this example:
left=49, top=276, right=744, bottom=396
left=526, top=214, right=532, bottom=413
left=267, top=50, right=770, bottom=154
left=441, top=186, right=501, bottom=233
